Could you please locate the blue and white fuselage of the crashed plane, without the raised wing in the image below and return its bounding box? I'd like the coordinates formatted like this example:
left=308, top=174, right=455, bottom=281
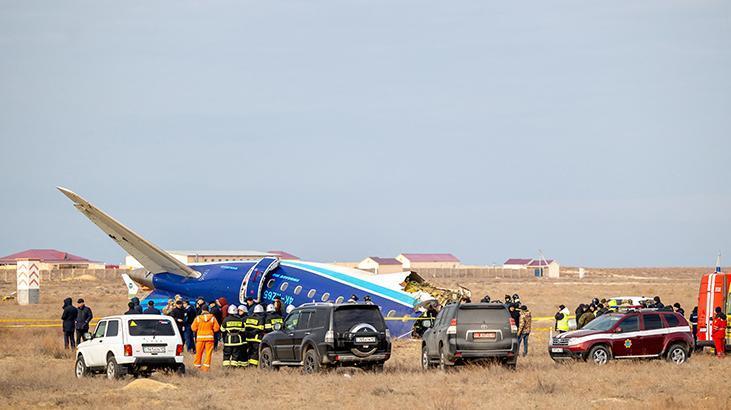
left=147, top=258, right=421, bottom=337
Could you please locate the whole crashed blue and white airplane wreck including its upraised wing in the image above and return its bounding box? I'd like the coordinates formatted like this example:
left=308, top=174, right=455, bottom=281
left=58, top=187, right=463, bottom=337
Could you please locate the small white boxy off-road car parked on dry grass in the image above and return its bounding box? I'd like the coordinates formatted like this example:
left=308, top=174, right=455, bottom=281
left=75, top=315, right=185, bottom=379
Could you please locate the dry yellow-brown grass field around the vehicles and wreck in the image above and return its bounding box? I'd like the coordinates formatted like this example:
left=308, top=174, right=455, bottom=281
left=0, top=268, right=731, bottom=409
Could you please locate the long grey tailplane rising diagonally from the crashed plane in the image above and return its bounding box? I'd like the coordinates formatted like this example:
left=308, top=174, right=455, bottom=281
left=57, top=187, right=200, bottom=278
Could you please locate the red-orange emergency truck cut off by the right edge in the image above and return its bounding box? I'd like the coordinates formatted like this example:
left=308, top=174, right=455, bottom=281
left=696, top=267, right=731, bottom=350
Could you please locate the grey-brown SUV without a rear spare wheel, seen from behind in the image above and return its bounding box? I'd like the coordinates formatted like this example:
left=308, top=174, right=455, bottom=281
left=421, top=303, right=518, bottom=369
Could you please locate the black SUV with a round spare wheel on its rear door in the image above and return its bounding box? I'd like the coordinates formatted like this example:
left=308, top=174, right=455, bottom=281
left=259, top=303, right=391, bottom=373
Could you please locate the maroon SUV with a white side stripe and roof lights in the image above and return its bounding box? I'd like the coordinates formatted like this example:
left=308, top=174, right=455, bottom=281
left=548, top=309, right=693, bottom=365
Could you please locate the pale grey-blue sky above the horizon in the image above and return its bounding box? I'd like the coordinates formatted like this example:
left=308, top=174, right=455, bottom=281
left=0, top=0, right=731, bottom=266
